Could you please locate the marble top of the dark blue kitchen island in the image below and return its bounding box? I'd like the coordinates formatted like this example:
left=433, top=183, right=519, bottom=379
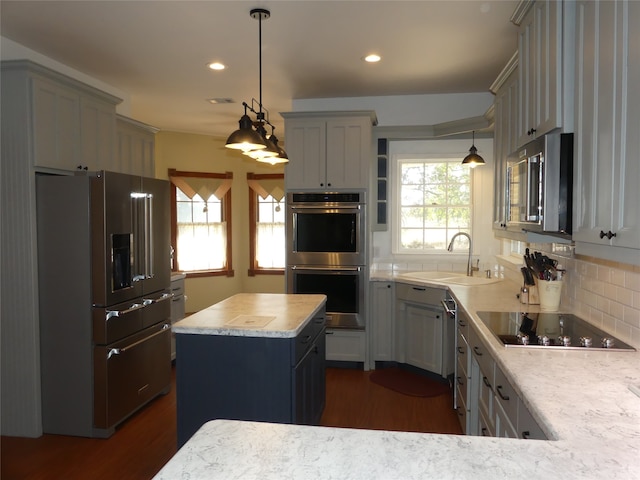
left=172, top=293, right=327, bottom=338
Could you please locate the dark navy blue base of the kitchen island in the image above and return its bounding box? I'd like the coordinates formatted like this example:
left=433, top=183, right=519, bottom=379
left=176, top=309, right=326, bottom=447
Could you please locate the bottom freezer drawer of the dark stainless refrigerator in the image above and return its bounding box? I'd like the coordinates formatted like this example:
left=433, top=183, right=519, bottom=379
left=94, top=322, right=171, bottom=430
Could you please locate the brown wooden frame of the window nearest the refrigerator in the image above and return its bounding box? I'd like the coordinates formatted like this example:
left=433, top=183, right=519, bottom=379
left=168, top=168, right=235, bottom=278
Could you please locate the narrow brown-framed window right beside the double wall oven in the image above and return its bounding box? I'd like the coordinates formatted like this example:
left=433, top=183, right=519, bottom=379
left=247, top=173, right=286, bottom=276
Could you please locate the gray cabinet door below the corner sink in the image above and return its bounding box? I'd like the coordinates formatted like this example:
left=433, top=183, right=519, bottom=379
left=405, top=304, right=443, bottom=374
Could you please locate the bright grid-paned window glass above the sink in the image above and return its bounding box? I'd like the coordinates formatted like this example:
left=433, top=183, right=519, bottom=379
left=395, top=155, right=472, bottom=254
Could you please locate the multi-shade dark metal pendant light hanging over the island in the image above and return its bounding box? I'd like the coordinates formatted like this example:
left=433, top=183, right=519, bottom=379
left=225, top=8, right=289, bottom=165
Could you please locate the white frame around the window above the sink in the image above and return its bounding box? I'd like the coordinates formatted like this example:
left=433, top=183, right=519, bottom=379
left=391, top=152, right=474, bottom=257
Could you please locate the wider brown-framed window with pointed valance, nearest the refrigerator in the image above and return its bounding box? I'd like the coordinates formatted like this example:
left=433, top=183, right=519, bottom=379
left=169, top=169, right=233, bottom=276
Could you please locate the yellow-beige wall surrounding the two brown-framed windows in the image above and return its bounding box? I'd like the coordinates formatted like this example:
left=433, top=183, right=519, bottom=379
left=155, top=132, right=285, bottom=313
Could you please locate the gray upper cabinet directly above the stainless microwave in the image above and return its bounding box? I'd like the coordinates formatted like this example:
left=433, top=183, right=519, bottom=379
left=512, top=0, right=573, bottom=146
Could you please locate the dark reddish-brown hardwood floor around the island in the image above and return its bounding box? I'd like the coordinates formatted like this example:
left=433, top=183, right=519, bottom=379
left=0, top=368, right=462, bottom=480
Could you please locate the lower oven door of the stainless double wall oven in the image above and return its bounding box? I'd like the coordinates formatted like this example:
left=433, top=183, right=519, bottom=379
left=287, top=265, right=365, bottom=330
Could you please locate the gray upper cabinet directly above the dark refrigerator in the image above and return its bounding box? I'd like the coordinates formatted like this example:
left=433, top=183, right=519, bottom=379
left=2, top=60, right=121, bottom=171
